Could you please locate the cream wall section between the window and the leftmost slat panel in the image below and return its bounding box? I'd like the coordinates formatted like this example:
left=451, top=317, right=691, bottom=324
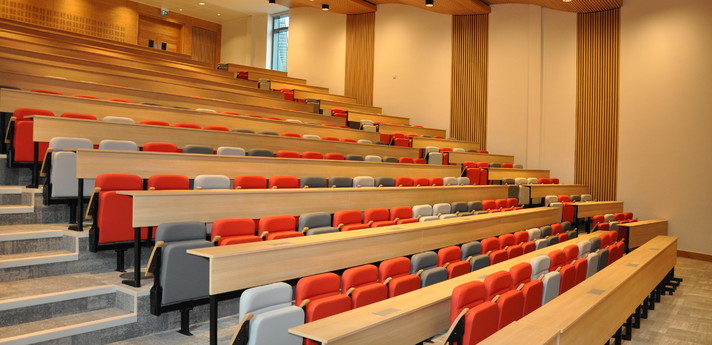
left=287, top=7, right=346, bottom=95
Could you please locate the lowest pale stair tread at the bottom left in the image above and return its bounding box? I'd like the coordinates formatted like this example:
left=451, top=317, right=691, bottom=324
left=0, top=308, right=133, bottom=343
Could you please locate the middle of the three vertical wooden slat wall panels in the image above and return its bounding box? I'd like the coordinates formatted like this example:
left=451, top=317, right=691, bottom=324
left=450, top=14, right=489, bottom=149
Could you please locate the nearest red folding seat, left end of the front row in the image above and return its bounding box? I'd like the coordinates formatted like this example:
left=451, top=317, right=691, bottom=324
left=448, top=281, right=499, bottom=344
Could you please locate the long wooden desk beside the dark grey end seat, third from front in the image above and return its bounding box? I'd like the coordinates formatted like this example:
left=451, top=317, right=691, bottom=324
left=191, top=207, right=556, bottom=292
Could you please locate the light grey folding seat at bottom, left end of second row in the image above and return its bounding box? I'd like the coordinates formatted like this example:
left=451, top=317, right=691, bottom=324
left=233, top=282, right=304, bottom=345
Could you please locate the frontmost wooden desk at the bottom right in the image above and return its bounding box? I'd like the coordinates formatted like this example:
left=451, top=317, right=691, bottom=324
left=480, top=236, right=677, bottom=345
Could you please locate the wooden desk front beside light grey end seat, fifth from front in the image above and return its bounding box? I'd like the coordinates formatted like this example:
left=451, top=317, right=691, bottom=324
left=76, top=150, right=460, bottom=179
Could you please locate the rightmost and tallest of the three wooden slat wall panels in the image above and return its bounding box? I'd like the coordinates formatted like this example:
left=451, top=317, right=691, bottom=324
left=574, top=9, right=620, bottom=200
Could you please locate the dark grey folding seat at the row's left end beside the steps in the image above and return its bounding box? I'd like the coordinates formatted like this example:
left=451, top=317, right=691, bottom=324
left=148, top=222, right=210, bottom=334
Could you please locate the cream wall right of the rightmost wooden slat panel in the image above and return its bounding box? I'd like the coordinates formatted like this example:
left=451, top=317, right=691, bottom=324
left=618, top=0, right=712, bottom=255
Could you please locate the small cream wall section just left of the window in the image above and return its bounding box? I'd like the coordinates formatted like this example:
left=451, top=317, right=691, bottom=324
left=220, top=14, right=269, bottom=68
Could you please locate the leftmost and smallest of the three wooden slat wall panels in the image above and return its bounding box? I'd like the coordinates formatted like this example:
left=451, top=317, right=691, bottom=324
left=344, top=12, right=376, bottom=105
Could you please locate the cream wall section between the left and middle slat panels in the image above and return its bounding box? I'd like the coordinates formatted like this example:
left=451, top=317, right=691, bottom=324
left=373, top=4, right=452, bottom=129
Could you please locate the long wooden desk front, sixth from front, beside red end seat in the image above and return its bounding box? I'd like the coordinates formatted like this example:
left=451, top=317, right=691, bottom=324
left=33, top=116, right=418, bottom=158
